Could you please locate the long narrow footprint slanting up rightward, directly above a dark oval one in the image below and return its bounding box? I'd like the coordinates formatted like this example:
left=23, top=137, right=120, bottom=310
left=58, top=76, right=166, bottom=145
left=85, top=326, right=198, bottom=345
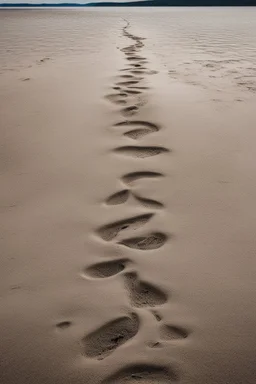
left=98, top=213, right=154, bottom=241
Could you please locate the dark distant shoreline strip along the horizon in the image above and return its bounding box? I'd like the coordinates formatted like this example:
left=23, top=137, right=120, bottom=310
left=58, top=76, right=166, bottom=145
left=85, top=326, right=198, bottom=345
left=0, top=0, right=256, bottom=8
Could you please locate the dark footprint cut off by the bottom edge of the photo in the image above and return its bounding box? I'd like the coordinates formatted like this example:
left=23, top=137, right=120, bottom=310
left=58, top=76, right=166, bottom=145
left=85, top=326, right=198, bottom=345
left=102, top=364, right=179, bottom=384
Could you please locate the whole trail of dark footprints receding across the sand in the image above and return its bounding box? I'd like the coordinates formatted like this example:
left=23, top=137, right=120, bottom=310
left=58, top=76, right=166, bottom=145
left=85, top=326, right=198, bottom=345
left=58, top=22, right=189, bottom=384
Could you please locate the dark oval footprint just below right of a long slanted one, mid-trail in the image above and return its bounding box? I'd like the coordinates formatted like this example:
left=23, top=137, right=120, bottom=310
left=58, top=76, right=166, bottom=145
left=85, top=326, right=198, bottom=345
left=118, top=232, right=167, bottom=251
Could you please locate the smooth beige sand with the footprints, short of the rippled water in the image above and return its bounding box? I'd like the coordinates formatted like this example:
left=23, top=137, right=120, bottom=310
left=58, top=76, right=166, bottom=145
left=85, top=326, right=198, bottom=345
left=0, top=8, right=256, bottom=384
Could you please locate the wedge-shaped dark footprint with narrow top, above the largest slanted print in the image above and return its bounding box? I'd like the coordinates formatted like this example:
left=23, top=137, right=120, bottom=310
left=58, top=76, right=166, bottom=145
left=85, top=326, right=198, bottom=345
left=123, top=272, right=167, bottom=308
